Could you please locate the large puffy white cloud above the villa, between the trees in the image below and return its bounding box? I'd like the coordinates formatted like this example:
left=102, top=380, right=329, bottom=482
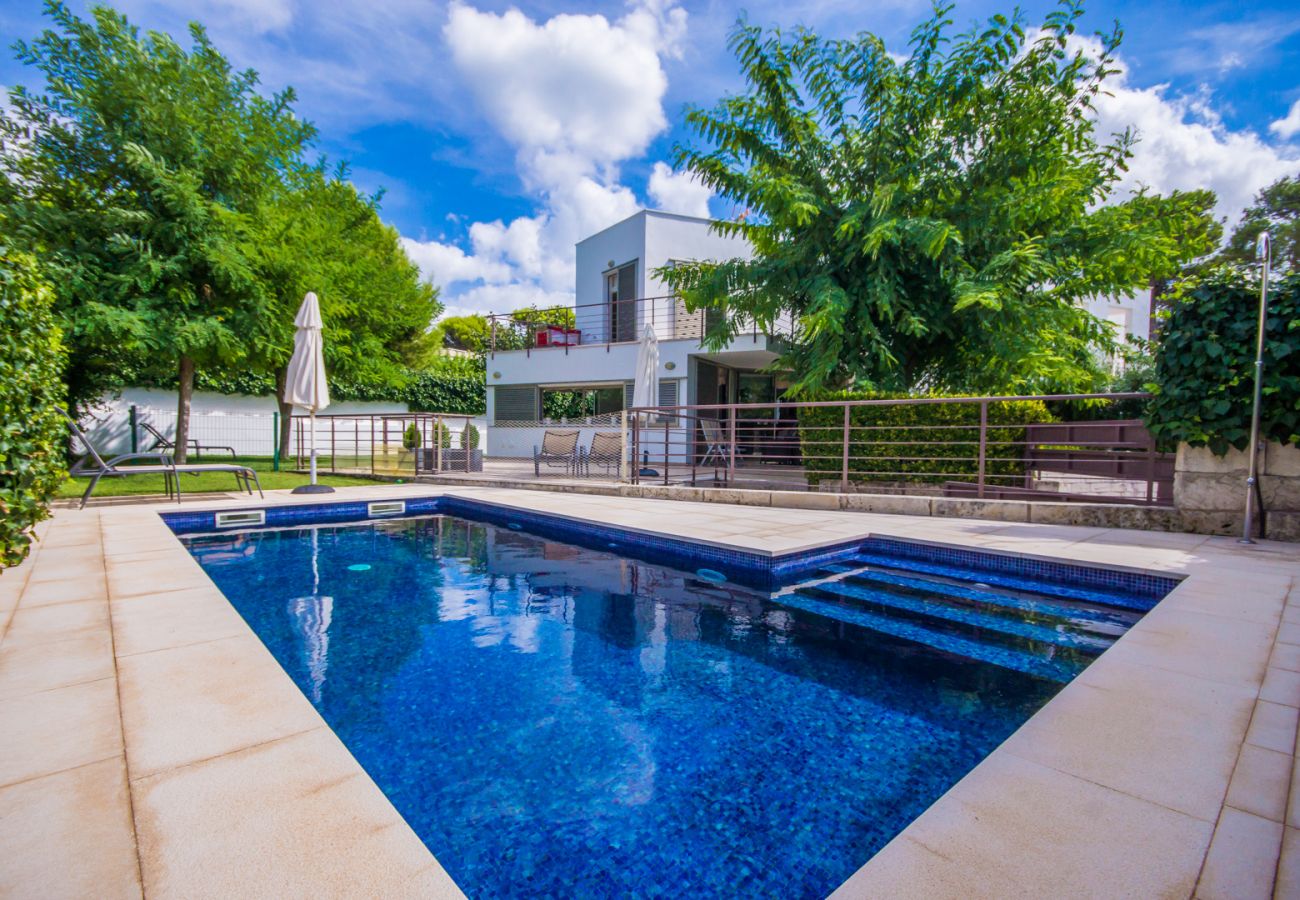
left=404, top=0, right=698, bottom=318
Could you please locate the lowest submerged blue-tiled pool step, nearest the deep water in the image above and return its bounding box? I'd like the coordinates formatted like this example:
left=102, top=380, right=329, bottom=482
left=772, top=589, right=1091, bottom=684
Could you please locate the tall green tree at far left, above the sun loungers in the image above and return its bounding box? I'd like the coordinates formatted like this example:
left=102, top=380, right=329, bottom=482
left=0, top=1, right=315, bottom=460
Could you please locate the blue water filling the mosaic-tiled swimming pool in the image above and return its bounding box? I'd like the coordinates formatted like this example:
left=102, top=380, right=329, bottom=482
left=185, top=515, right=1140, bottom=897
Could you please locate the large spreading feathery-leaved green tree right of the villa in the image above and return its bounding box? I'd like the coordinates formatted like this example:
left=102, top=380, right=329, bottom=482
left=659, top=1, right=1217, bottom=393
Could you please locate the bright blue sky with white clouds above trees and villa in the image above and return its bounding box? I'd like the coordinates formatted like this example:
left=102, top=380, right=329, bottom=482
left=0, top=0, right=1300, bottom=312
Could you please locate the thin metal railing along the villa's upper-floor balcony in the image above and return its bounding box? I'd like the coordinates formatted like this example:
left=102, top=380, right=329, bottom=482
left=488, top=297, right=792, bottom=352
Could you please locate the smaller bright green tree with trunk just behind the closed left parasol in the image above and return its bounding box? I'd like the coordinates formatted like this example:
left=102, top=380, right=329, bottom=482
left=246, top=166, right=442, bottom=454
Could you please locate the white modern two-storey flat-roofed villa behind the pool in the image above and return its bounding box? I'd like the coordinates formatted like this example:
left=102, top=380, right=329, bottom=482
left=486, top=209, right=1151, bottom=457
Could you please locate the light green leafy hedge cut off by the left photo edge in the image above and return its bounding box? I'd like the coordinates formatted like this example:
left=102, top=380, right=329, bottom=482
left=0, top=247, right=68, bottom=568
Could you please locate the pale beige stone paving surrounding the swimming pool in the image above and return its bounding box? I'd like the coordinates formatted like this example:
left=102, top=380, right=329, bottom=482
left=0, top=485, right=1300, bottom=897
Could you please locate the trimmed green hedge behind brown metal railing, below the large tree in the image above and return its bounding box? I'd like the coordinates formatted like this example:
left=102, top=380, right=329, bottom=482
left=800, top=393, right=1053, bottom=486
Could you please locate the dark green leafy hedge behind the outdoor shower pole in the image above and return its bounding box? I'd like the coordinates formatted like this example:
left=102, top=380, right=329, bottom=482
left=1147, top=269, right=1300, bottom=455
